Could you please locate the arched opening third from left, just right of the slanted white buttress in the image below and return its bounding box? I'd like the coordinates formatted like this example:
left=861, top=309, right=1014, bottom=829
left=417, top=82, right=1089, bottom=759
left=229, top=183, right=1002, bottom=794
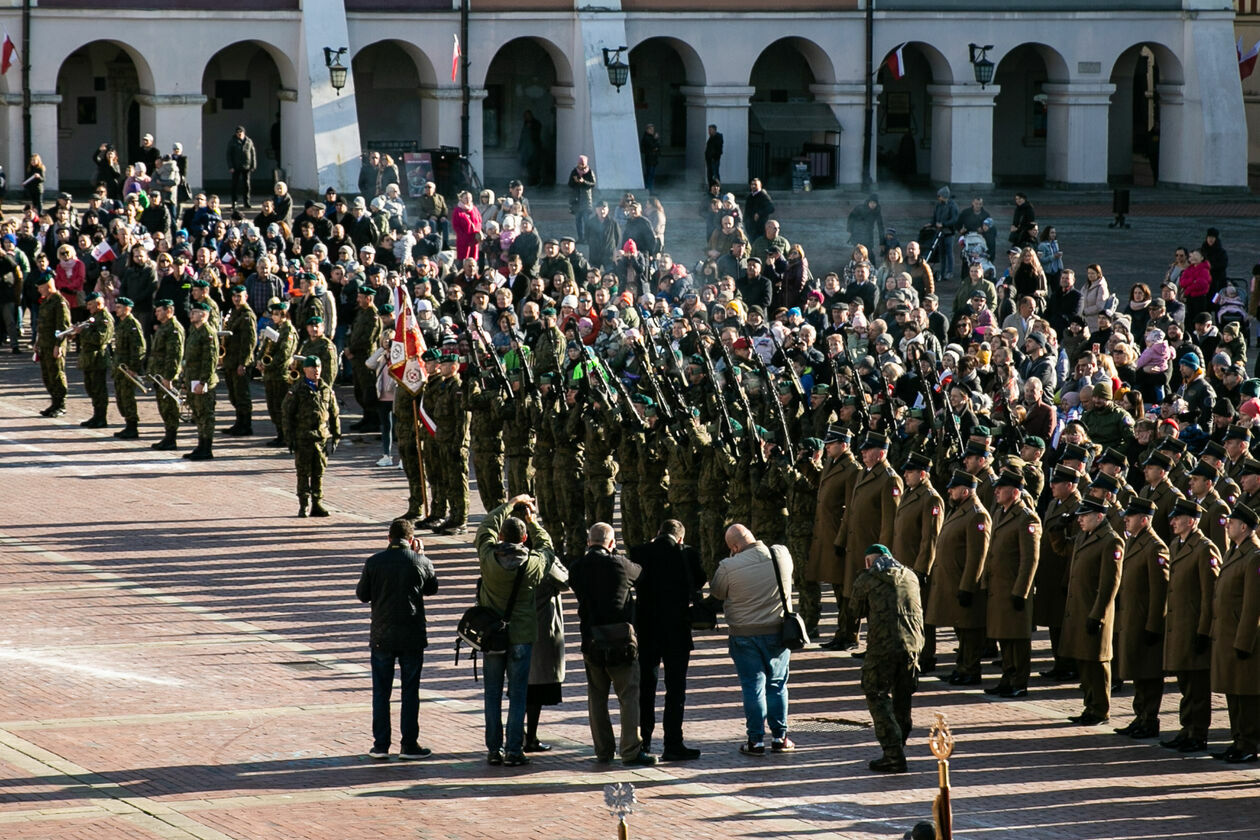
left=352, top=40, right=435, bottom=171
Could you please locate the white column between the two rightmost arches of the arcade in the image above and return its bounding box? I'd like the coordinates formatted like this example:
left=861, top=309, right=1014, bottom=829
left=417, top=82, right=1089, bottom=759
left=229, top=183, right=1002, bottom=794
left=1042, top=83, right=1115, bottom=189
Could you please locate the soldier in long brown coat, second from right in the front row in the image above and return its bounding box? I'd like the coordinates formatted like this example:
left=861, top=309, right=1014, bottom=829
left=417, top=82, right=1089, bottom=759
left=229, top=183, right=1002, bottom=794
left=1159, top=499, right=1221, bottom=753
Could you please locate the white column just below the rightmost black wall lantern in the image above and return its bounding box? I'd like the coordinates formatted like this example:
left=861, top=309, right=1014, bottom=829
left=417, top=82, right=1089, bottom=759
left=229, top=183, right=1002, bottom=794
left=927, top=84, right=1000, bottom=190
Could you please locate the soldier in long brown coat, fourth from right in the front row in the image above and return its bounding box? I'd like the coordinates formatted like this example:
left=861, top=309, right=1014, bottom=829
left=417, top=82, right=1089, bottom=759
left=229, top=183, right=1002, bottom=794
left=1058, top=499, right=1124, bottom=727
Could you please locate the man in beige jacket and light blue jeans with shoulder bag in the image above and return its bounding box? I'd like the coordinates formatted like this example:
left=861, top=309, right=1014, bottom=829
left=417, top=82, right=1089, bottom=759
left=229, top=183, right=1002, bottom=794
left=709, top=525, right=796, bottom=756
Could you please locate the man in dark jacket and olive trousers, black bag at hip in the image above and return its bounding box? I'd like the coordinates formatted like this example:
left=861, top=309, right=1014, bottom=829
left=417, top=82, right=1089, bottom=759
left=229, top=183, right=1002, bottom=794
left=568, top=523, right=656, bottom=767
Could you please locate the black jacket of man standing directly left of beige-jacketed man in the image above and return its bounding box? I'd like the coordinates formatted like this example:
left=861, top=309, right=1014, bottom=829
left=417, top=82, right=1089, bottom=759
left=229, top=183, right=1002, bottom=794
left=630, top=536, right=704, bottom=651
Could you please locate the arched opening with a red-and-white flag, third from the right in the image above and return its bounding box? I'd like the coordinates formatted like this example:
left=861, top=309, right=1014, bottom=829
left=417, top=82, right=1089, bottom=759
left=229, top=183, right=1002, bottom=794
left=876, top=43, right=953, bottom=185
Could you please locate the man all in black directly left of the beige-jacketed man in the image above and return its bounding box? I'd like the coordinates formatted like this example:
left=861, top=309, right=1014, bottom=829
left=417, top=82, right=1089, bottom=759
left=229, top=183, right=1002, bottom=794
left=630, top=519, right=706, bottom=761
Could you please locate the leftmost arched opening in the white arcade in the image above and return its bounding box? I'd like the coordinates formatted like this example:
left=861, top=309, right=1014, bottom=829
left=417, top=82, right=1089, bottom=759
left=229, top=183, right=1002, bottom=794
left=54, top=40, right=151, bottom=189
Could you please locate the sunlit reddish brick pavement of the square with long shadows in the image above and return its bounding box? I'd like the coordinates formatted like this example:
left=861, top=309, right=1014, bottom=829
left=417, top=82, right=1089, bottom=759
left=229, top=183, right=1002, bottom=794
left=0, top=347, right=1260, bottom=840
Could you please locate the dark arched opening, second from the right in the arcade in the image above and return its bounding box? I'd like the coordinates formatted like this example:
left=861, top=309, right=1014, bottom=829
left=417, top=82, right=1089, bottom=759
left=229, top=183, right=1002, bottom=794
left=993, top=44, right=1051, bottom=184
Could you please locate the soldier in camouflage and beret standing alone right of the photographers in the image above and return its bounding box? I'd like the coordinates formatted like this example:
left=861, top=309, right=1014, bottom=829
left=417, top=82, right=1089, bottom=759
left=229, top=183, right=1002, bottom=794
left=852, top=544, right=924, bottom=773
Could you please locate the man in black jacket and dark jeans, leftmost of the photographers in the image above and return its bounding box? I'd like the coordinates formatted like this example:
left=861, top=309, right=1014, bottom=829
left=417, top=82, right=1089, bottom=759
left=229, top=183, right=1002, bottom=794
left=355, top=519, right=437, bottom=761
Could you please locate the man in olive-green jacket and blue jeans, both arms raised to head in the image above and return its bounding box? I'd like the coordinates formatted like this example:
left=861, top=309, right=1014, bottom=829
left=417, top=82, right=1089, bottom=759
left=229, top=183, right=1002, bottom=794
left=474, top=494, right=554, bottom=767
